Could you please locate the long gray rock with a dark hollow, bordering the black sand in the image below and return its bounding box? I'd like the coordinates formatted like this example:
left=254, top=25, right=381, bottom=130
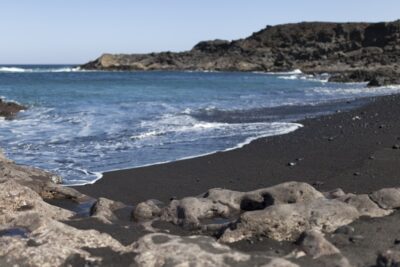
left=158, top=182, right=324, bottom=228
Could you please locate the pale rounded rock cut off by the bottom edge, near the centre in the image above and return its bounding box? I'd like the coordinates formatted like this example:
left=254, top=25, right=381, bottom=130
left=133, top=233, right=297, bottom=267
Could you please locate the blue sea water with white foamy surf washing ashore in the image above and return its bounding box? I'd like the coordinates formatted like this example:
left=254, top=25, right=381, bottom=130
left=0, top=65, right=400, bottom=184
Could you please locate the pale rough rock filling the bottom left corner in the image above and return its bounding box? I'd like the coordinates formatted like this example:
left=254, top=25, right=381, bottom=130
left=0, top=212, right=127, bottom=267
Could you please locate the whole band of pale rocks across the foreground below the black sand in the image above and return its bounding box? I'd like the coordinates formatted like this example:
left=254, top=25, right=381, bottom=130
left=0, top=148, right=400, bottom=267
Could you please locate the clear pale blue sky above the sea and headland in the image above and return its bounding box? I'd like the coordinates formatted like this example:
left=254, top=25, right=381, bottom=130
left=0, top=0, right=400, bottom=64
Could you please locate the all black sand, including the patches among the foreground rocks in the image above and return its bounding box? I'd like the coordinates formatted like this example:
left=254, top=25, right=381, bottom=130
left=69, top=95, right=400, bottom=266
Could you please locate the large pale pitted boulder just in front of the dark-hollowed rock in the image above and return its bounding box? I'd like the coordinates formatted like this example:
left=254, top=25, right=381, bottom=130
left=220, top=199, right=360, bottom=243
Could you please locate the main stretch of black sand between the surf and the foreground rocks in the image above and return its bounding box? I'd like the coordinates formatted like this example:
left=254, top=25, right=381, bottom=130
left=76, top=93, right=400, bottom=205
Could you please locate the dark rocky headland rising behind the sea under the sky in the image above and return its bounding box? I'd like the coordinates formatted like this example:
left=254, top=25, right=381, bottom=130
left=80, top=20, right=400, bottom=86
